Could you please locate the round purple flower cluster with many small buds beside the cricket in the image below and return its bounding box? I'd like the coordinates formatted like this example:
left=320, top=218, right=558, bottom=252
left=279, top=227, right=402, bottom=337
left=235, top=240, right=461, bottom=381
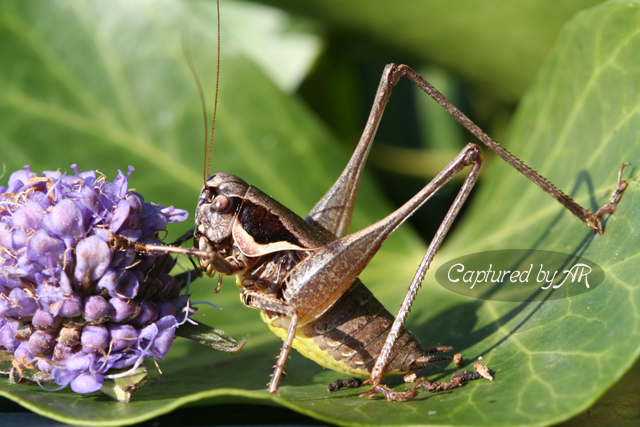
left=0, top=165, right=189, bottom=393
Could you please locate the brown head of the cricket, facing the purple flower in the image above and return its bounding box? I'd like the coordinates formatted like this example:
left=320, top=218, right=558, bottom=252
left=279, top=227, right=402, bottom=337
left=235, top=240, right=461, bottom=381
left=194, top=173, right=249, bottom=276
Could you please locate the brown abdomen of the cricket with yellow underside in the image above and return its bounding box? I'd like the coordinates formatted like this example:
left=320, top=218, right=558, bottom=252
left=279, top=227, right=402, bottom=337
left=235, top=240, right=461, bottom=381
left=263, top=280, right=425, bottom=378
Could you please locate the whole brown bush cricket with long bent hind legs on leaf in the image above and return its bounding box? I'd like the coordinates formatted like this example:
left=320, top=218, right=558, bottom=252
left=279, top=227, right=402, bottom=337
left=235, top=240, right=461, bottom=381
left=114, top=7, right=628, bottom=401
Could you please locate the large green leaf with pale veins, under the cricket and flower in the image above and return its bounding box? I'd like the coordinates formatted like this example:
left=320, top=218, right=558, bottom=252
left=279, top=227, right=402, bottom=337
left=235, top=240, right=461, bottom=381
left=0, top=1, right=640, bottom=425
